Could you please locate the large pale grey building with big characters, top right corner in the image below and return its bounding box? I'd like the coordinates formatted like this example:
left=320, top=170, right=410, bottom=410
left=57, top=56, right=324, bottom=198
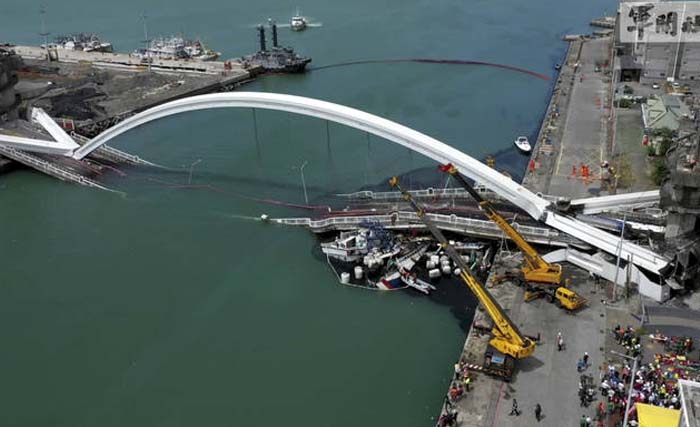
left=616, top=0, right=700, bottom=81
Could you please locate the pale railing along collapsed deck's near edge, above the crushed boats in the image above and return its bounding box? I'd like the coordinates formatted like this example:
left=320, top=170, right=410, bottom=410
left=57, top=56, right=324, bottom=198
left=270, top=212, right=587, bottom=247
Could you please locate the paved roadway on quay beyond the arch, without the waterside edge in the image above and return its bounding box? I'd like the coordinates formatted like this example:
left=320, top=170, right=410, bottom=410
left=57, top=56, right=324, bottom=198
left=548, top=39, right=610, bottom=198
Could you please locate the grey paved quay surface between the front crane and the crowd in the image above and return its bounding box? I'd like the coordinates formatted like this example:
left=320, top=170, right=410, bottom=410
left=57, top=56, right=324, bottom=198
left=494, top=265, right=605, bottom=427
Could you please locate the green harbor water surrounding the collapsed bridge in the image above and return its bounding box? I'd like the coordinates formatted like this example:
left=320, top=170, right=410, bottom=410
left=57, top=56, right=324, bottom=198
left=0, top=0, right=615, bottom=427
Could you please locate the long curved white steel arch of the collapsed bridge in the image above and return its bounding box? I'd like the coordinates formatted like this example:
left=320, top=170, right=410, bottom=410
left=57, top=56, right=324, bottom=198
left=73, top=92, right=668, bottom=274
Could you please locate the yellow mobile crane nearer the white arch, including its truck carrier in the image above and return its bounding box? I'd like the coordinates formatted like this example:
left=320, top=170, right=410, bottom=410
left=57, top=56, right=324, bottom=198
left=440, top=163, right=586, bottom=310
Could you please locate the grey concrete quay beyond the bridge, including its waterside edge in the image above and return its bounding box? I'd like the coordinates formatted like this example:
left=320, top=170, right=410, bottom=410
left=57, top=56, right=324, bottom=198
left=523, top=37, right=613, bottom=198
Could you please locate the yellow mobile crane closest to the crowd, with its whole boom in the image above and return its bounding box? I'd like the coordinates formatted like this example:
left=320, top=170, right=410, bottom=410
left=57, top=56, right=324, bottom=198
left=389, top=177, right=535, bottom=380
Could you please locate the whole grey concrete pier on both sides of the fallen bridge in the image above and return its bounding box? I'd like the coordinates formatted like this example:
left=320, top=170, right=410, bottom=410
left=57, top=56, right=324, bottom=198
left=432, top=37, right=628, bottom=427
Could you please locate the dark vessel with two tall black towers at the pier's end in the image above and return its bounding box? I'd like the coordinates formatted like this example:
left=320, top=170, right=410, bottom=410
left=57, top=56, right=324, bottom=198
left=243, top=22, right=311, bottom=73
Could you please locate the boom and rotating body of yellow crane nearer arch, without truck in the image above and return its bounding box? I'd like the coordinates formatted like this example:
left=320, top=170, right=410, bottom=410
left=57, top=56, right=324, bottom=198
left=440, top=163, right=561, bottom=285
